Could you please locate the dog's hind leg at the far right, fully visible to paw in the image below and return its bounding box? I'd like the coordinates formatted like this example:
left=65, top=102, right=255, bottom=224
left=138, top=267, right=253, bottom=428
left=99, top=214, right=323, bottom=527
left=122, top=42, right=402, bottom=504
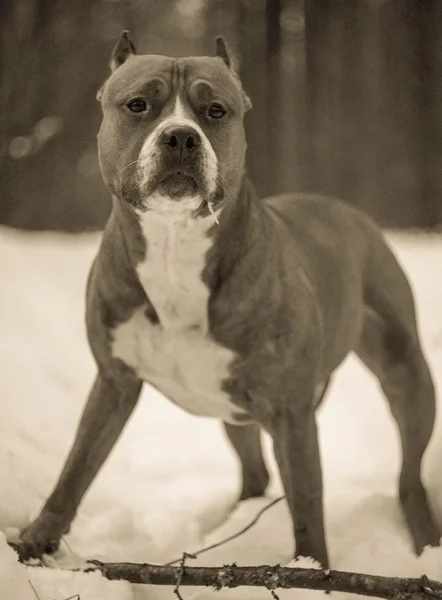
left=356, top=305, right=440, bottom=554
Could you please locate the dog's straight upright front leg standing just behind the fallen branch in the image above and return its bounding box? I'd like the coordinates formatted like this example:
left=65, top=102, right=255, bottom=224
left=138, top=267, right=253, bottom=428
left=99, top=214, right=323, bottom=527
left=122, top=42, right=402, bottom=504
left=272, top=407, right=329, bottom=568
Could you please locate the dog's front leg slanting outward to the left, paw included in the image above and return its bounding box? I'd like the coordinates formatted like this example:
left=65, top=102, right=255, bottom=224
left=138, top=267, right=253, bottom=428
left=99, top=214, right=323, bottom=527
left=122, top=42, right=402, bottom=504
left=16, top=375, right=141, bottom=559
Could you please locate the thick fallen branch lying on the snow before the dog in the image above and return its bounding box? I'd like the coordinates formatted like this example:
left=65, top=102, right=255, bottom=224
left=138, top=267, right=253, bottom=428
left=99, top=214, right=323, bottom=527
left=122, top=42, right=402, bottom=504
left=88, top=561, right=442, bottom=600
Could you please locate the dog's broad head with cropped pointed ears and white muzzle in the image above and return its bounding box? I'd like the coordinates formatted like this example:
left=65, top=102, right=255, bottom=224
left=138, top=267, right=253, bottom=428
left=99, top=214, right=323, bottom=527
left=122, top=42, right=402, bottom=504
left=98, top=34, right=248, bottom=215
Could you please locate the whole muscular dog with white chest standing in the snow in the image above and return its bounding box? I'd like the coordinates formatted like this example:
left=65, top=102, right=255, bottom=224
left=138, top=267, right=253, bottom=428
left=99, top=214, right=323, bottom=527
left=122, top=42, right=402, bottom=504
left=18, top=32, right=440, bottom=568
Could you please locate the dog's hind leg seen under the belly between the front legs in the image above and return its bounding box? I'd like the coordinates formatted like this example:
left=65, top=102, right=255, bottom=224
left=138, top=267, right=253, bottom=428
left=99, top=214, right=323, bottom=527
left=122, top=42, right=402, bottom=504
left=224, top=423, right=269, bottom=500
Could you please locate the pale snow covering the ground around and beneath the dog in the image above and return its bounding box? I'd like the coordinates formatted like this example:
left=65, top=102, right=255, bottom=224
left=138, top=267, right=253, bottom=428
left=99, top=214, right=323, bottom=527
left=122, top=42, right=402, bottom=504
left=0, top=228, right=442, bottom=600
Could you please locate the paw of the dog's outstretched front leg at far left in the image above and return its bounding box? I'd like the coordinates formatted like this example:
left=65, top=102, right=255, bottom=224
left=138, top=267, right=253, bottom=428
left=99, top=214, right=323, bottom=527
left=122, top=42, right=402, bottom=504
left=9, top=512, right=67, bottom=562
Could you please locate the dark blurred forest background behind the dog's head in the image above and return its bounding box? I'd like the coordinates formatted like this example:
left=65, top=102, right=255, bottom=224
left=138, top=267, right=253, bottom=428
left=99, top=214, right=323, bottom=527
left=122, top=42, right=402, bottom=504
left=0, top=0, right=442, bottom=231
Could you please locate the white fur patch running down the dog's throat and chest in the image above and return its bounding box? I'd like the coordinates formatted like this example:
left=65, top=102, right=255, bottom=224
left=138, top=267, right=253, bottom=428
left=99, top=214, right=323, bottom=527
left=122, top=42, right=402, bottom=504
left=112, top=204, right=242, bottom=422
